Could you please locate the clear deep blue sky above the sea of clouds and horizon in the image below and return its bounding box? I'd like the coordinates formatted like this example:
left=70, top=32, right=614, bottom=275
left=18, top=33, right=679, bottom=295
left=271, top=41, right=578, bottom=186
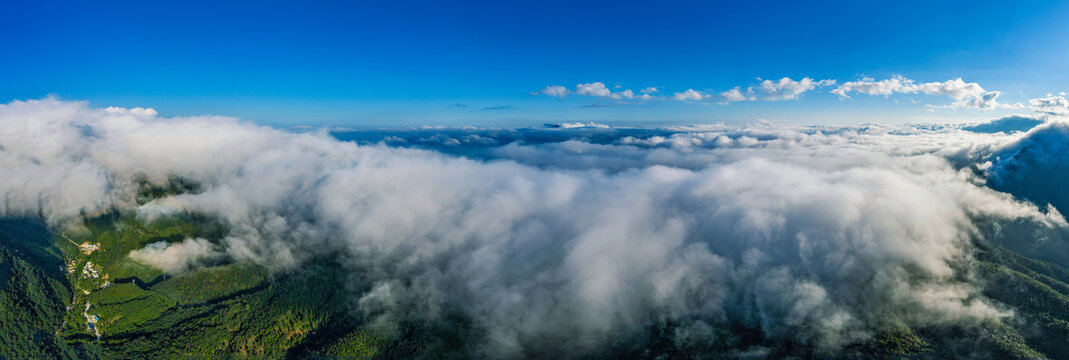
left=0, top=1, right=1069, bottom=127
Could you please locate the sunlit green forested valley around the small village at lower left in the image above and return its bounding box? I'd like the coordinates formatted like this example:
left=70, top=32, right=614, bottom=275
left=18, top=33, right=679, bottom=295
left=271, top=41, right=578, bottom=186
left=0, top=213, right=382, bottom=359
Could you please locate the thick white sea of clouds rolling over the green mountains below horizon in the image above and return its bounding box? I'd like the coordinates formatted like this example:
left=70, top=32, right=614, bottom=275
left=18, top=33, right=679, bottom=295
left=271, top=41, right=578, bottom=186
left=0, top=98, right=1069, bottom=357
